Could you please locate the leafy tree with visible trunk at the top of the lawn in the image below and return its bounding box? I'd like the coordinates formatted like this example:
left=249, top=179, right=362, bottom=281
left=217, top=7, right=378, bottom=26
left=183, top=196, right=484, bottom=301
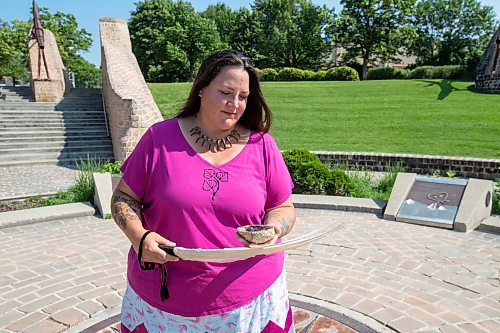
left=332, top=0, right=415, bottom=80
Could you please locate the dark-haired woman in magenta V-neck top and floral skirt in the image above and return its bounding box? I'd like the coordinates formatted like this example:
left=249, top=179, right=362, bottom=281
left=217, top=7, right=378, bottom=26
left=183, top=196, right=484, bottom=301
left=112, top=51, right=295, bottom=333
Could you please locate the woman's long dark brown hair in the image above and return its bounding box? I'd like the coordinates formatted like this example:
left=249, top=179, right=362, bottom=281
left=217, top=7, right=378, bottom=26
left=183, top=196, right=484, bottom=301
left=175, top=50, right=272, bottom=133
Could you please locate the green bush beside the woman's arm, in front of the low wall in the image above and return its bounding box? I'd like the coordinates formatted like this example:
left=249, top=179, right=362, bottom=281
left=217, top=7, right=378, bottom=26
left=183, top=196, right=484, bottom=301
left=283, top=149, right=353, bottom=196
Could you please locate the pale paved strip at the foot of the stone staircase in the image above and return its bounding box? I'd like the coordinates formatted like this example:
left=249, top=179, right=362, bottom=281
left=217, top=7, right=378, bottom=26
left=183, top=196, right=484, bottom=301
left=0, top=165, right=78, bottom=200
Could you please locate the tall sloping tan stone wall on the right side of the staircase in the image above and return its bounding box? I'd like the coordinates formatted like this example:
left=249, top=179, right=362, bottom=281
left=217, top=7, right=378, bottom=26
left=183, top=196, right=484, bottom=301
left=99, top=17, right=163, bottom=161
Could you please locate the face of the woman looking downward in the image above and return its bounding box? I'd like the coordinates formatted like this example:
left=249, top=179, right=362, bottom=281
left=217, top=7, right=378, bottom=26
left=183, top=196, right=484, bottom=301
left=198, top=66, right=250, bottom=135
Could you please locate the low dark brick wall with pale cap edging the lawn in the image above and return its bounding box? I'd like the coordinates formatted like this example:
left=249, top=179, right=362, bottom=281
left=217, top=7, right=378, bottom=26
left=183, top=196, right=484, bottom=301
left=313, top=151, right=500, bottom=180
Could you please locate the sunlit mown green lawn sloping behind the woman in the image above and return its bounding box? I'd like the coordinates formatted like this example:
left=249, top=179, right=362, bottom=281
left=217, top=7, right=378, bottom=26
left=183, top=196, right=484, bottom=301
left=149, top=80, right=500, bottom=158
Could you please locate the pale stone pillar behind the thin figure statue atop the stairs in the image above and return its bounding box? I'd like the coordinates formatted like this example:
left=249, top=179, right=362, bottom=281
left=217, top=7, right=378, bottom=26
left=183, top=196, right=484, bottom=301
left=28, top=29, right=70, bottom=102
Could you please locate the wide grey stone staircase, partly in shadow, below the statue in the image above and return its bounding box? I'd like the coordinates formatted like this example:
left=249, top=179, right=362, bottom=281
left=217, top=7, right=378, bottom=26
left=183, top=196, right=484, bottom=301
left=0, top=87, right=113, bottom=166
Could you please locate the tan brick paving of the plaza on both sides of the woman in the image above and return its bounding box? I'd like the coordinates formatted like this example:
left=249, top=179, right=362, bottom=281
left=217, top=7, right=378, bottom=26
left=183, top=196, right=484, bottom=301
left=0, top=209, right=500, bottom=333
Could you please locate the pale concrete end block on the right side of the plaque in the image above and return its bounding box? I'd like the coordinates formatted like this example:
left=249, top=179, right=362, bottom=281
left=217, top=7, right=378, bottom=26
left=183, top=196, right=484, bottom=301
left=453, top=178, right=493, bottom=232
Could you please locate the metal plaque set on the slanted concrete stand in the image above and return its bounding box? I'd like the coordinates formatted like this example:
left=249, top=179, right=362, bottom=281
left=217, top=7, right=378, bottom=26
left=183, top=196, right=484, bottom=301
left=396, top=176, right=467, bottom=229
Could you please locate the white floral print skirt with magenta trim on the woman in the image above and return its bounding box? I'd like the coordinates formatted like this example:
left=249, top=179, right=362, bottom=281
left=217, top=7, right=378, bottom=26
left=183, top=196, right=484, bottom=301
left=121, top=270, right=295, bottom=333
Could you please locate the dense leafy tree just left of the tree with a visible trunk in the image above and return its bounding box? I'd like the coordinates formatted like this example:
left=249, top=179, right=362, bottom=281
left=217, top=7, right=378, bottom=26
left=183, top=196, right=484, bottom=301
left=252, top=0, right=331, bottom=69
